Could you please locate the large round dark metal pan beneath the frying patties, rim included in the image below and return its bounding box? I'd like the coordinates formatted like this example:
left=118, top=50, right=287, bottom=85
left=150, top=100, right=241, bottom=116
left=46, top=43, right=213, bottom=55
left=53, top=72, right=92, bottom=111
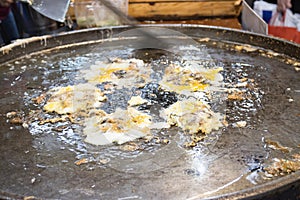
left=0, top=25, right=300, bottom=199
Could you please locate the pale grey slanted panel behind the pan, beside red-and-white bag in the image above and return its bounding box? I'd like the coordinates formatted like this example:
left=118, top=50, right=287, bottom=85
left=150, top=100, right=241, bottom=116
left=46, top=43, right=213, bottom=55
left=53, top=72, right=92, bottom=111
left=242, top=0, right=268, bottom=35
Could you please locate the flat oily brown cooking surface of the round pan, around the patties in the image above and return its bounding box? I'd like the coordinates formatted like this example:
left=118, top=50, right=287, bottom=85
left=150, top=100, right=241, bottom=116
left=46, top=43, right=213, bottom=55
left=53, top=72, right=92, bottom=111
left=0, top=25, right=300, bottom=199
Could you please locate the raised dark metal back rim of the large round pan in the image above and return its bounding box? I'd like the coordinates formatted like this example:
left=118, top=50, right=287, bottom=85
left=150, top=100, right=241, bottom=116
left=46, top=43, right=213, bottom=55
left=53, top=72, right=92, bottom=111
left=0, top=24, right=300, bottom=63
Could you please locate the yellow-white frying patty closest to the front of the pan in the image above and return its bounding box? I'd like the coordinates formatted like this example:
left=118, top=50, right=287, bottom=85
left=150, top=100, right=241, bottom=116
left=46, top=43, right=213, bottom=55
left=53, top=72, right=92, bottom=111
left=83, top=107, right=152, bottom=145
